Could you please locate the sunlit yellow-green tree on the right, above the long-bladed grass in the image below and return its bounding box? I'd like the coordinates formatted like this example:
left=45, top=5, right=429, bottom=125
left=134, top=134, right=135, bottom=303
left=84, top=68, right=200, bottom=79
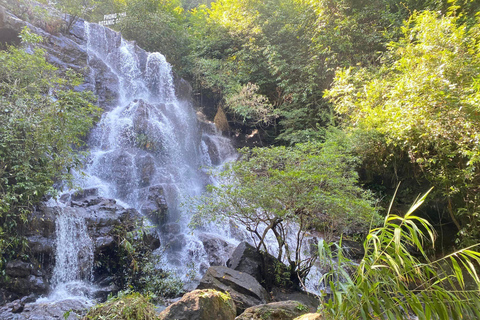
left=328, top=11, right=480, bottom=245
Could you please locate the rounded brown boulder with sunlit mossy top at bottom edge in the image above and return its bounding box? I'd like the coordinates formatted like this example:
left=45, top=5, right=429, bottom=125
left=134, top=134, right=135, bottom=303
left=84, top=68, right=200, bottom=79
left=159, top=290, right=236, bottom=320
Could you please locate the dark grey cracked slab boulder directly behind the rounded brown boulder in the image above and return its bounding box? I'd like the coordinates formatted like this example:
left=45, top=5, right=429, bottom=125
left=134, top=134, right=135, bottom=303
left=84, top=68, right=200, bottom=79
left=197, top=266, right=270, bottom=314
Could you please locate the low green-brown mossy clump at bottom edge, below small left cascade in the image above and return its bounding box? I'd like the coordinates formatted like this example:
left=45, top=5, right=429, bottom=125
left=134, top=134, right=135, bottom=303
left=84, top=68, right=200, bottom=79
left=82, top=292, right=158, bottom=320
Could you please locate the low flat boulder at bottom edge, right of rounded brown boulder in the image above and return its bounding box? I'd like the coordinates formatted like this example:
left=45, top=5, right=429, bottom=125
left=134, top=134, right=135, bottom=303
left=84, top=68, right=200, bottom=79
left=235, top=300, right=308, bottom=320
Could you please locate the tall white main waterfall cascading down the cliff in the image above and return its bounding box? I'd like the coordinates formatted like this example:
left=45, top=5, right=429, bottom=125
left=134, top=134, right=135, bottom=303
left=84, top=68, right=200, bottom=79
left=73, top=22, right=235, bottom=277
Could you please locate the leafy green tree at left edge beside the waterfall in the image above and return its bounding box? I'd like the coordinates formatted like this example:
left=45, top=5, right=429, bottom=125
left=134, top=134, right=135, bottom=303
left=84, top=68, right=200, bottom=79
left=0, top=29, right=100, bottom=267
